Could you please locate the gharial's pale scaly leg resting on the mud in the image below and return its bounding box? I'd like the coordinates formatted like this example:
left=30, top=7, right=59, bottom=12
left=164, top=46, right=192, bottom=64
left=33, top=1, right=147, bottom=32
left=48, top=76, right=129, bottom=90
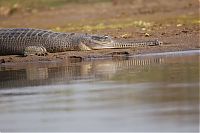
left=24, top=46, right=47, bottom=56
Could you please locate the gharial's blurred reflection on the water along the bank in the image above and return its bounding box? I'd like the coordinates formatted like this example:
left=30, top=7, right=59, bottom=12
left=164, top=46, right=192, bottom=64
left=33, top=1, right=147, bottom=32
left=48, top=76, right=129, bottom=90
left=0, top=58, right=164, bottom=88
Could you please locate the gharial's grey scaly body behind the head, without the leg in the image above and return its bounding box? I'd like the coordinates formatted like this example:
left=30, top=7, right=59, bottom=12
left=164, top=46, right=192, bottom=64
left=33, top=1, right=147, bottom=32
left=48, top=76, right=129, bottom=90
left=0, top=28, right=83, bottom=55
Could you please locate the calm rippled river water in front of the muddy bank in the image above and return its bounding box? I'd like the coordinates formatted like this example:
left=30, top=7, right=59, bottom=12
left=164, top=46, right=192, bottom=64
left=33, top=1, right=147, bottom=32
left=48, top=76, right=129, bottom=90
left=0, top=51, right=199, bottom=132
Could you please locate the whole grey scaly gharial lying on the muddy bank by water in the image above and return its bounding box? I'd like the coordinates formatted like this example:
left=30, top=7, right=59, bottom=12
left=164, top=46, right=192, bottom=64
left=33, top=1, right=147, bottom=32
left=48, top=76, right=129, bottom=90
left=0, top=28, right=162, bottom=56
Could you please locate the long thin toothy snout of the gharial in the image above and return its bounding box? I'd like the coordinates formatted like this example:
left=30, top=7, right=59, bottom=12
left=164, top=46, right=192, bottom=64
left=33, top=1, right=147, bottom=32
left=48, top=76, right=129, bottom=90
left=113, top=40, right=162, bottom=48
